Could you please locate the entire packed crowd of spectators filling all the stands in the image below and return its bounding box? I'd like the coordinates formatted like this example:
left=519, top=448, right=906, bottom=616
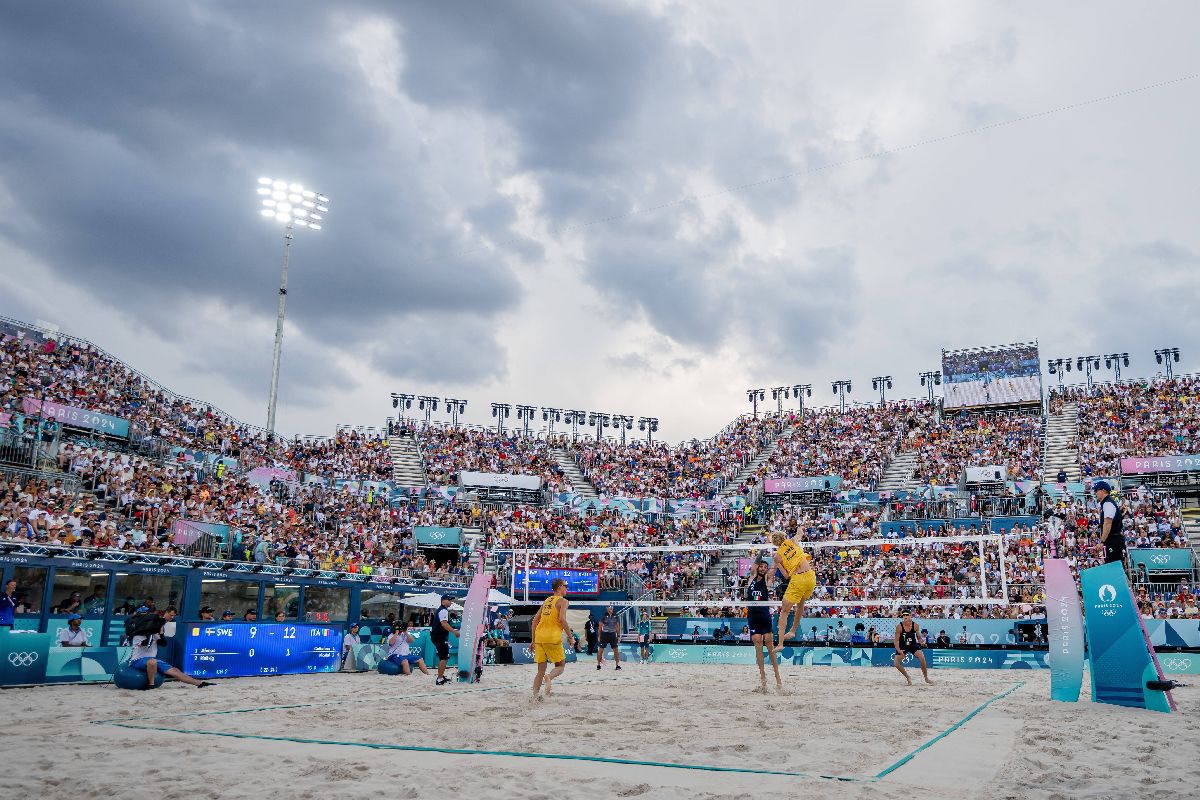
left=0, top=316, right=1200, bottom=616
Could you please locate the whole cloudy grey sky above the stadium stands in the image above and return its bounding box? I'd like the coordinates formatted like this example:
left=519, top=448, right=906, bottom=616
left=0, top=0, right=1200, bottom=440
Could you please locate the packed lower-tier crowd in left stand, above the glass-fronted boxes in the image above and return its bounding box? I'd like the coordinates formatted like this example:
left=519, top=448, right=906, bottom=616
left=0, top=443, right=469, bottom=579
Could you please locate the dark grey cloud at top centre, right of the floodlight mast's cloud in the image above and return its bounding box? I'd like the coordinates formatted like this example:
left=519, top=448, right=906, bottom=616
left=388, top=2, right=858, bottom=361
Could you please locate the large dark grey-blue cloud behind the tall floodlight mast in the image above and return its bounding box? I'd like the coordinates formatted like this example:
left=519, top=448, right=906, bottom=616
left=0, top=2, right=525, bottom=379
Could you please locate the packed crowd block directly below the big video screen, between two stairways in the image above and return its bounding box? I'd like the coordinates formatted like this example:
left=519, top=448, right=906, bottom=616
left=910, top=414, right=1042, bottom=486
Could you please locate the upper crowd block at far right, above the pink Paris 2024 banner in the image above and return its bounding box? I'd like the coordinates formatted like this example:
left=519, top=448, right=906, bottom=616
left=1054, top=378, right=1200, bottom=476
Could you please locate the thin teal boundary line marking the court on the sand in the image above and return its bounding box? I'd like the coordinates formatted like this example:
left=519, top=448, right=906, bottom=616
left=91, top=678, right=1025, bottom=783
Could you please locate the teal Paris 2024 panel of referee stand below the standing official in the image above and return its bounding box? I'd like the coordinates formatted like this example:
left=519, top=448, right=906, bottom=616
left=1079, top=561, right=1171, bottom=712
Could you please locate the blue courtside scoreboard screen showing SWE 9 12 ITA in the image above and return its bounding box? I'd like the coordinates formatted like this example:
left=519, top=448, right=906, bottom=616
left=180, top=622, right=342, bottom=678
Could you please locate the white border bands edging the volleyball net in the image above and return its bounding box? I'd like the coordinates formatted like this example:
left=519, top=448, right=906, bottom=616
left=496, top=534, right=1009, bottom=610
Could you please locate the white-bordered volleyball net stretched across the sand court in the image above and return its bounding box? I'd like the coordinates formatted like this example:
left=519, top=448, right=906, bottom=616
left=497, top=534, right=1009, bottom=612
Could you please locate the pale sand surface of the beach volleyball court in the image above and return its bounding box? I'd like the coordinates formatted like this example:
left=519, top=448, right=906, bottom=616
left=0, top=663, right=1200, bottom=800
